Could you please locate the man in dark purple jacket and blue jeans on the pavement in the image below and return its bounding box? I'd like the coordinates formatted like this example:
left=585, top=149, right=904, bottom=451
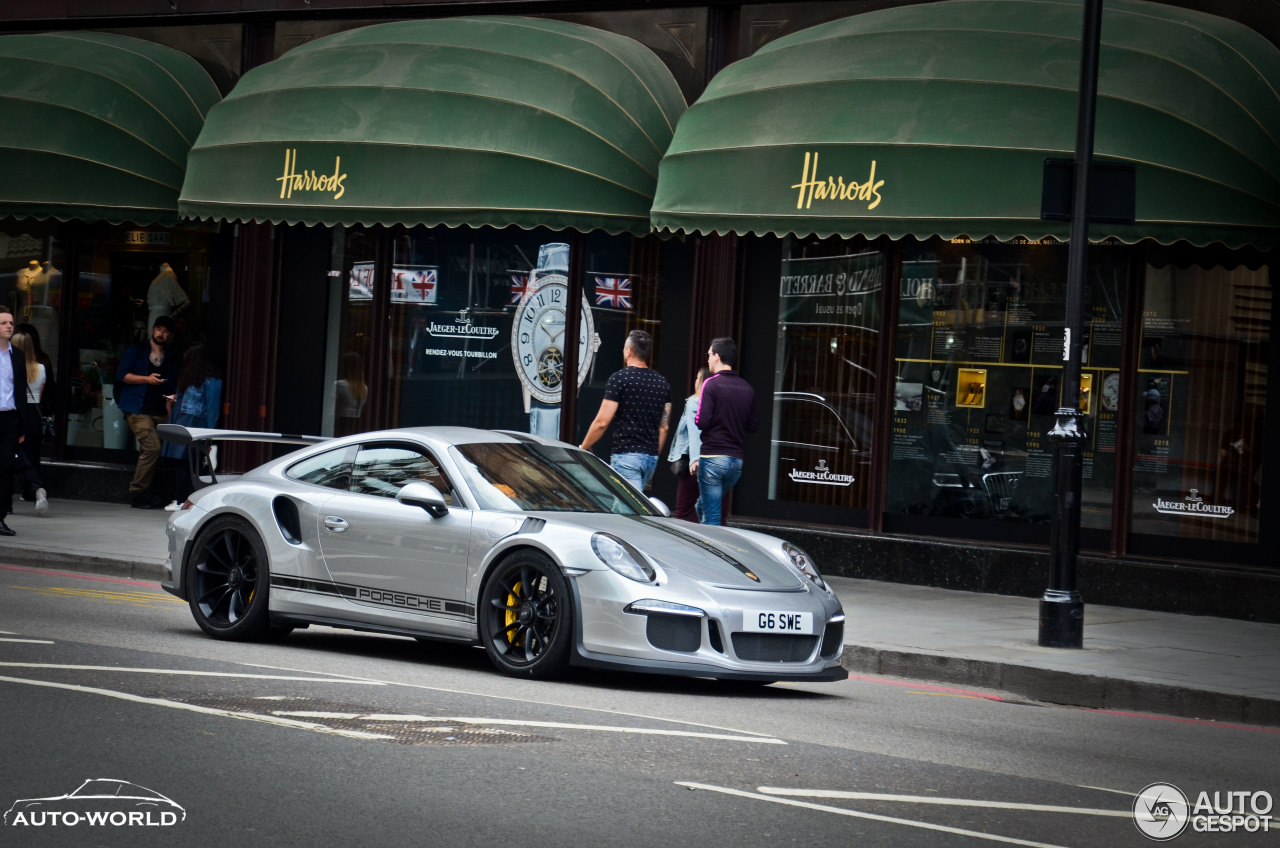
left=694, top=338, right=755, bottom=524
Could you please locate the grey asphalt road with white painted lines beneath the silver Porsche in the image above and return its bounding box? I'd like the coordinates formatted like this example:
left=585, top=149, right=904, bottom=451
left=0, top=566, right=1280, bottom=848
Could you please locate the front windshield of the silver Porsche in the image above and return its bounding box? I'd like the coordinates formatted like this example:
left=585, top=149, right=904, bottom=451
left=451, top=442, right=658, bottom=515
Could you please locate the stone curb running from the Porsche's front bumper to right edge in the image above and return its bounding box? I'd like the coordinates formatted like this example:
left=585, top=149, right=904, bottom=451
left=840, top=646, right=1280, bottom=726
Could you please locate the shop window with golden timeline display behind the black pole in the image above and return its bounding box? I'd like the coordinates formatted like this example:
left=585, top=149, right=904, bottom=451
left=886, top=241, right=1125, bottom=529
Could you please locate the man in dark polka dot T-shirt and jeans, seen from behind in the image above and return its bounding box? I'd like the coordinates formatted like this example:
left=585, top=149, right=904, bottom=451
left=580, top=329, right=671, bottom=492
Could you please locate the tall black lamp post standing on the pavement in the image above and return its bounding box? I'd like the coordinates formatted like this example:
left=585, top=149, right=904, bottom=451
left=1039, top=0, right=1102, bottom=648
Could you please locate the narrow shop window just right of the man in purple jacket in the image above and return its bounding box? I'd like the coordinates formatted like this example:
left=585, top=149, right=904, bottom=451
left=769, top=240, right=884, bottom=509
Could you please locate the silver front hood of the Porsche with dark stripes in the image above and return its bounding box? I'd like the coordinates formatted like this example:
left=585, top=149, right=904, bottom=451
left=545, top=512, right=804, bottom=592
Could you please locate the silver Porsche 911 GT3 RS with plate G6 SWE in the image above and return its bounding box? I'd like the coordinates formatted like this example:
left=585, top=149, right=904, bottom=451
left=163, top=425, right=847, bottom=680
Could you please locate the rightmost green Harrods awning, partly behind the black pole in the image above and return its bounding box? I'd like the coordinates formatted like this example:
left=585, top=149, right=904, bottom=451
left=653, top=0, right=1280, bottom=247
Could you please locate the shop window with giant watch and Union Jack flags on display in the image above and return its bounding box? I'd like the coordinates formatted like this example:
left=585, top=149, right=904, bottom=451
left=329, top=228, right=660, bottom=438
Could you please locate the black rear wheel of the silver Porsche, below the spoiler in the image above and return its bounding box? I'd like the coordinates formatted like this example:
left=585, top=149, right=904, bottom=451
left=187, top=515, right=272, bottom=642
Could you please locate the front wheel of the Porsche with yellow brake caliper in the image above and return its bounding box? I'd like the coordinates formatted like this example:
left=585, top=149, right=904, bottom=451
left=479, top=551, right=573, bottom=680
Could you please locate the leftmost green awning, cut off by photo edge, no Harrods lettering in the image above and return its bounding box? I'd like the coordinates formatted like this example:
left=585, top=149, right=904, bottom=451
left=0, top=32, right=219, bottom=225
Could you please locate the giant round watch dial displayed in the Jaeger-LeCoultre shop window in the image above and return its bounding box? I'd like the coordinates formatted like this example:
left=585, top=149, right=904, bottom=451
left=511, top=274, right=595, bottom=404
